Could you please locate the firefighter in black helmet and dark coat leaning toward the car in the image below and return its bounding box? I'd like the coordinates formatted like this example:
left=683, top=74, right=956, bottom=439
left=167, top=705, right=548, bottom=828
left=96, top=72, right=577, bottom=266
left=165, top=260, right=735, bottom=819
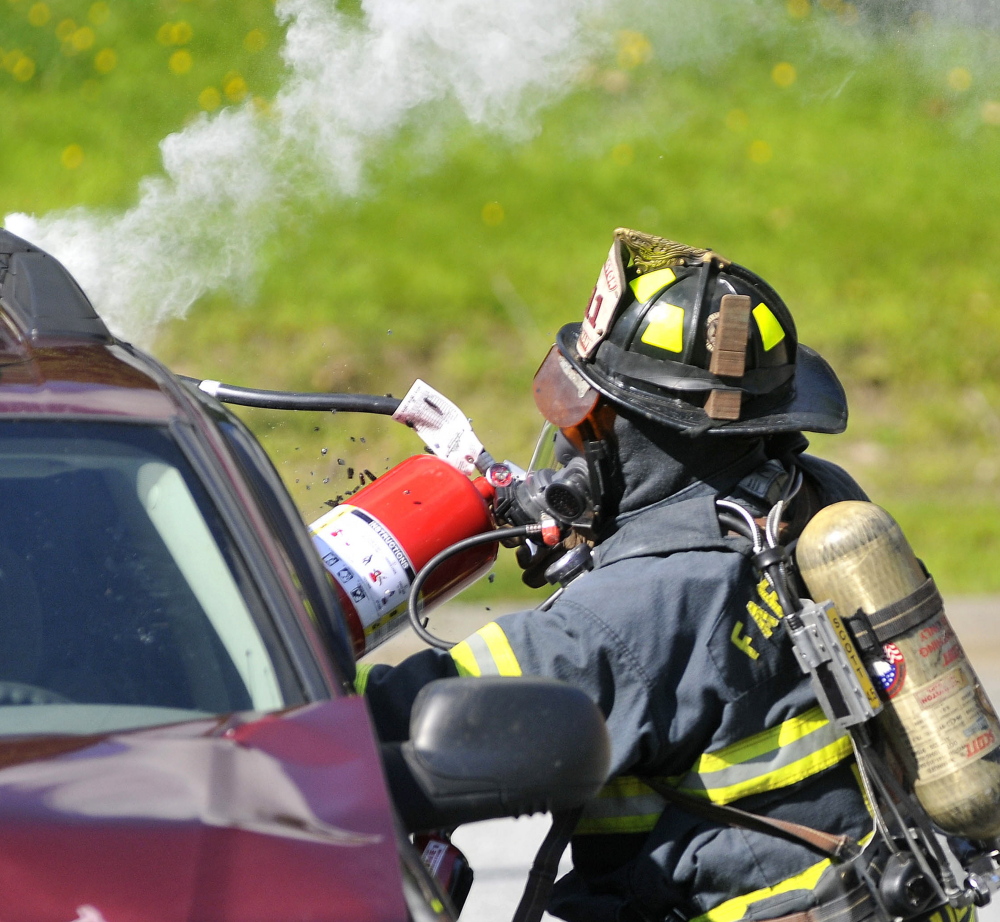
left=358, top=229, right=920, bottom=922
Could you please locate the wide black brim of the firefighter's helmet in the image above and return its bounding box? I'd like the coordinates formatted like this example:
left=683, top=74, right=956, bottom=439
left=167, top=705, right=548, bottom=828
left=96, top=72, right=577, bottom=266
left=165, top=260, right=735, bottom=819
left=556, top=323, right=847, bottom=435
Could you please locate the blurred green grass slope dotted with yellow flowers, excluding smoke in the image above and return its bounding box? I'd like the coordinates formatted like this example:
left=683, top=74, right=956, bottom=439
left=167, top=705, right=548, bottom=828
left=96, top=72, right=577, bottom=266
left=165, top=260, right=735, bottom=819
left=0, top=0, right=1000, bottom=595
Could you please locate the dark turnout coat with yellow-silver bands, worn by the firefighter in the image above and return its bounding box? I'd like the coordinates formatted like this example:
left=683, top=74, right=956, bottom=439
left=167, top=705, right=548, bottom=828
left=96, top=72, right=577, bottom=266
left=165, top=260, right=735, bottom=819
left=358, top=450, right=872, bottom=922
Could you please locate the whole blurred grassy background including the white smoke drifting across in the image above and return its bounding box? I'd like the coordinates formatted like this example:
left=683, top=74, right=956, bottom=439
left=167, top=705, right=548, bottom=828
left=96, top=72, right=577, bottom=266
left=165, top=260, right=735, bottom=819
left=0, top=0, right=1000, bottom=600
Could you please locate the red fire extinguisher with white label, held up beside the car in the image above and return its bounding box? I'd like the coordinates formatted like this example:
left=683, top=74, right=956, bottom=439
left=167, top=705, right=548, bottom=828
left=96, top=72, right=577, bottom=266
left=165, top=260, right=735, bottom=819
left=310, top=455, right=498, bottom=656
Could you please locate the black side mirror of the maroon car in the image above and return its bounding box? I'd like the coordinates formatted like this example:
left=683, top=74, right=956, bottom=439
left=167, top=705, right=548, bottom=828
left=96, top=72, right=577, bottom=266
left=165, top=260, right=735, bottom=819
left=383, top=676, right=611, bottom=832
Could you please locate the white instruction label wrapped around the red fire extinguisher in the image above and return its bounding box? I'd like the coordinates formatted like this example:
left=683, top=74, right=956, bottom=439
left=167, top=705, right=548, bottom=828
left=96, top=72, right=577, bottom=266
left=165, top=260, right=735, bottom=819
left=310, top=504, right=414, bottom=642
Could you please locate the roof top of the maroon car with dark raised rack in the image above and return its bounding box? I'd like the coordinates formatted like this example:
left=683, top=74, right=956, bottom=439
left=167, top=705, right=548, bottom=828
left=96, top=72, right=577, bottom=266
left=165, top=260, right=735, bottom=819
left=0, top=229, right=185, bottom=423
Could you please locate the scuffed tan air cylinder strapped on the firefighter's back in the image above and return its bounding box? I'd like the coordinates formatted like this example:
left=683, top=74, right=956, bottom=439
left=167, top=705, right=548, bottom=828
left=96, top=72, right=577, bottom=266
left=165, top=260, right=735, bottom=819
left=795, top=502, right=1000, bottom=840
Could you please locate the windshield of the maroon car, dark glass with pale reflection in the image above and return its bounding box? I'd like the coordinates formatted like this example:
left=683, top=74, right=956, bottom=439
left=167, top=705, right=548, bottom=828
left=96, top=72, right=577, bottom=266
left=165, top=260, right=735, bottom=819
left=0, top=420, right=300, bottom=736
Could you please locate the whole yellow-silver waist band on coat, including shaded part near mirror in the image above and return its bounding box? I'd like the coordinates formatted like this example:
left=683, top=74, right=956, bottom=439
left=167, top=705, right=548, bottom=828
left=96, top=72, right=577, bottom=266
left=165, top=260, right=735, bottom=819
left=576, top=707, right=853, bottom=835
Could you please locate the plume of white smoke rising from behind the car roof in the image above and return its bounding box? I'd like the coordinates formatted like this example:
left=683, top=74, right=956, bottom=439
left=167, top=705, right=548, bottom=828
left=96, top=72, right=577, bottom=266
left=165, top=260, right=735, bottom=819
left=5, top=0, right=609, bottom=343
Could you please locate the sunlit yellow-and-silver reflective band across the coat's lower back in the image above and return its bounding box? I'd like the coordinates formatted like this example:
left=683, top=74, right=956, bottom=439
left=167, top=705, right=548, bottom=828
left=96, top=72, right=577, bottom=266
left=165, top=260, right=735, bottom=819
left=671, top=707, right=854, bottom=804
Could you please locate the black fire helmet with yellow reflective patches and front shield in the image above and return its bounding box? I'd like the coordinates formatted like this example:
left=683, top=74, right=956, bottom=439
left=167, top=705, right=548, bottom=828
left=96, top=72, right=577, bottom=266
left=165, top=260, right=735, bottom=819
left=539, top=228, right=847, bottom=435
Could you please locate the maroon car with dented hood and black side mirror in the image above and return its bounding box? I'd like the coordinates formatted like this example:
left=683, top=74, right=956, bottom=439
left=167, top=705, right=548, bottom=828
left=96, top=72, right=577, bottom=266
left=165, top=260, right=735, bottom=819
left=0, top=230, right=607, bottom=922
